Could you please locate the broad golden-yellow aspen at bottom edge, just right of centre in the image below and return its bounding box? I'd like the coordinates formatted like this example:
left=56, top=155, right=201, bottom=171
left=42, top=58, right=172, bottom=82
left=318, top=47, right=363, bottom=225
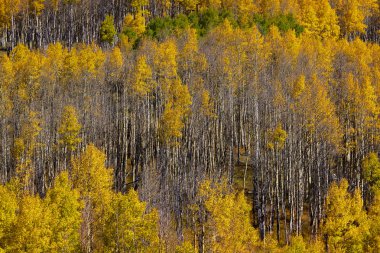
left=199, top=181, right=258, bottom=253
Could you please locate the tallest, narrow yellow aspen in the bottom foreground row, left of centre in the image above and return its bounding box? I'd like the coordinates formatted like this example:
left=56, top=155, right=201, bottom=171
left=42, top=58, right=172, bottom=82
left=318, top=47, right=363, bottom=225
left=72, top=144, right=113, bottom=251
